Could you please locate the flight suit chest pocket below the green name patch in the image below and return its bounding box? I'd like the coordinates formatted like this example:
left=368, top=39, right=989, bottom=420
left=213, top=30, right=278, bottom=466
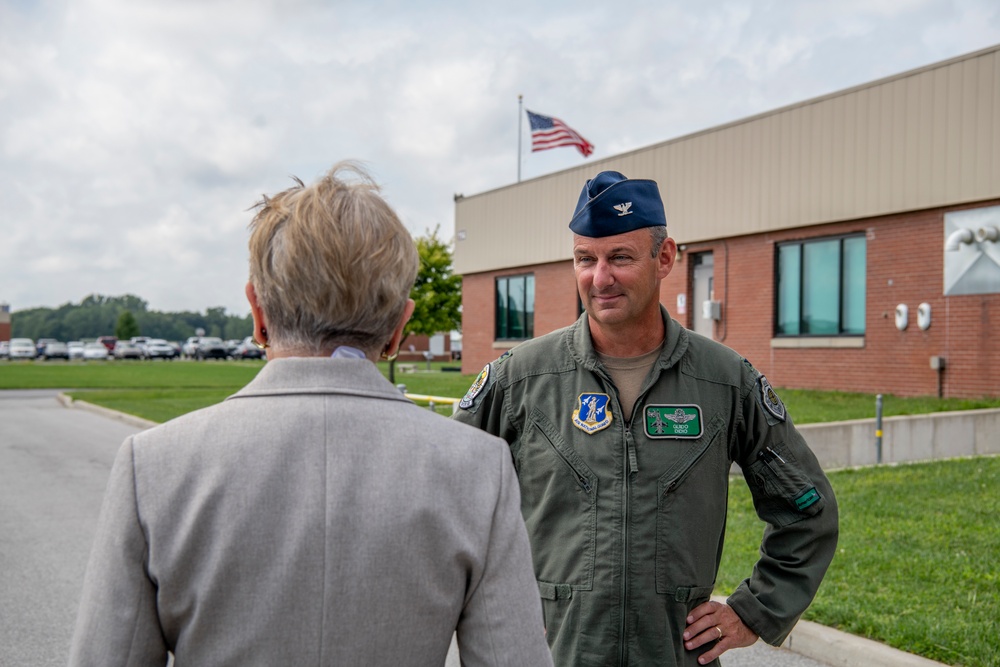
left=656, top=416, right=731, bottom=602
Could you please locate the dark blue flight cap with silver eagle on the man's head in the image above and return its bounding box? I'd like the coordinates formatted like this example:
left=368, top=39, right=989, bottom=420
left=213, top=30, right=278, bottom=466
left=569, top=171, right=667, bottom=238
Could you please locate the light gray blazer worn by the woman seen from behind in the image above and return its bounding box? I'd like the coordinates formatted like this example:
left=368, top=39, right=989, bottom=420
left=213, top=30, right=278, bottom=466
left=69, top=358, right=552, bottom=667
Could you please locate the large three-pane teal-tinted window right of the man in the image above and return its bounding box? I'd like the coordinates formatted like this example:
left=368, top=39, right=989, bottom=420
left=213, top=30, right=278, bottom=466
left=775, top=236, right=866, bottom=336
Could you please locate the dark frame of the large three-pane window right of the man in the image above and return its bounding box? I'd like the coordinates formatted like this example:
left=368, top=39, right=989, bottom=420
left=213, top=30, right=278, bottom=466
left=771, top=232, right=868, bottom=339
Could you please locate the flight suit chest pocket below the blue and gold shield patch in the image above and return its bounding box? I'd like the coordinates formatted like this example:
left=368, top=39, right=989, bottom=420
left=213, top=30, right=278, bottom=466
left=512, top=409, right=597, bottom=590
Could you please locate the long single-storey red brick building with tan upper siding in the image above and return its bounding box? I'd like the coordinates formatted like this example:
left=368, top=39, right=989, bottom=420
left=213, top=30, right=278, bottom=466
left=455, top=45, right=1000, bottom=397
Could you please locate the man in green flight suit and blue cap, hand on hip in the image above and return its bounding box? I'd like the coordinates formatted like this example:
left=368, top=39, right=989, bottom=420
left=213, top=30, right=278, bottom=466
left=456, top=171, right=838, bottom=667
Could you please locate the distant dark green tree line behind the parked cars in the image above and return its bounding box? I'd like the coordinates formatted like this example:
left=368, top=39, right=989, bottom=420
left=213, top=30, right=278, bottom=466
left=10, top=294, right=253, bottom=341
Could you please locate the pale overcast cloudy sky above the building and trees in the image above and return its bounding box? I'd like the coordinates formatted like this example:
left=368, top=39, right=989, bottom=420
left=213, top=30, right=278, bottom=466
left=0, top=0, right=1000, bottom=315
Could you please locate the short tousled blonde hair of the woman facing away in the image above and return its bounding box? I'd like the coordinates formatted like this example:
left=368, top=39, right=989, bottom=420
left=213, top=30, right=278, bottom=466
left=250, top=161, right=419, bottom=355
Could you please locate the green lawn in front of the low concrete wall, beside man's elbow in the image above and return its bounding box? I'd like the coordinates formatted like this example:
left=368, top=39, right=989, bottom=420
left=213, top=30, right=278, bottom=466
left=717, top=457, right=1000, bottom=667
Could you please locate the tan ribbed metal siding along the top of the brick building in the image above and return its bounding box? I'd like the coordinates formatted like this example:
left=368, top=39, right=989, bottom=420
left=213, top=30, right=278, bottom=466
left=455, top=46, right=1000, bottom=273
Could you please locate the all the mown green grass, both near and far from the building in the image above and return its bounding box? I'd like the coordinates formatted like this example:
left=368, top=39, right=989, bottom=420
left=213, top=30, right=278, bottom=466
left=0, top=362, right=1000, bottom=667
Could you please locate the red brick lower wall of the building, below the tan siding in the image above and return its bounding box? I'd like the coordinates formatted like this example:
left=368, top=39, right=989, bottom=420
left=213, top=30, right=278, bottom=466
left=462, top=201, right=1000, bottom=397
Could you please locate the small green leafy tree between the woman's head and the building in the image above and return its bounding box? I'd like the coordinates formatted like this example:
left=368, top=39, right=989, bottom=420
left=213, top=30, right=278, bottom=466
left=389, top=227, right=462, bottom=383
